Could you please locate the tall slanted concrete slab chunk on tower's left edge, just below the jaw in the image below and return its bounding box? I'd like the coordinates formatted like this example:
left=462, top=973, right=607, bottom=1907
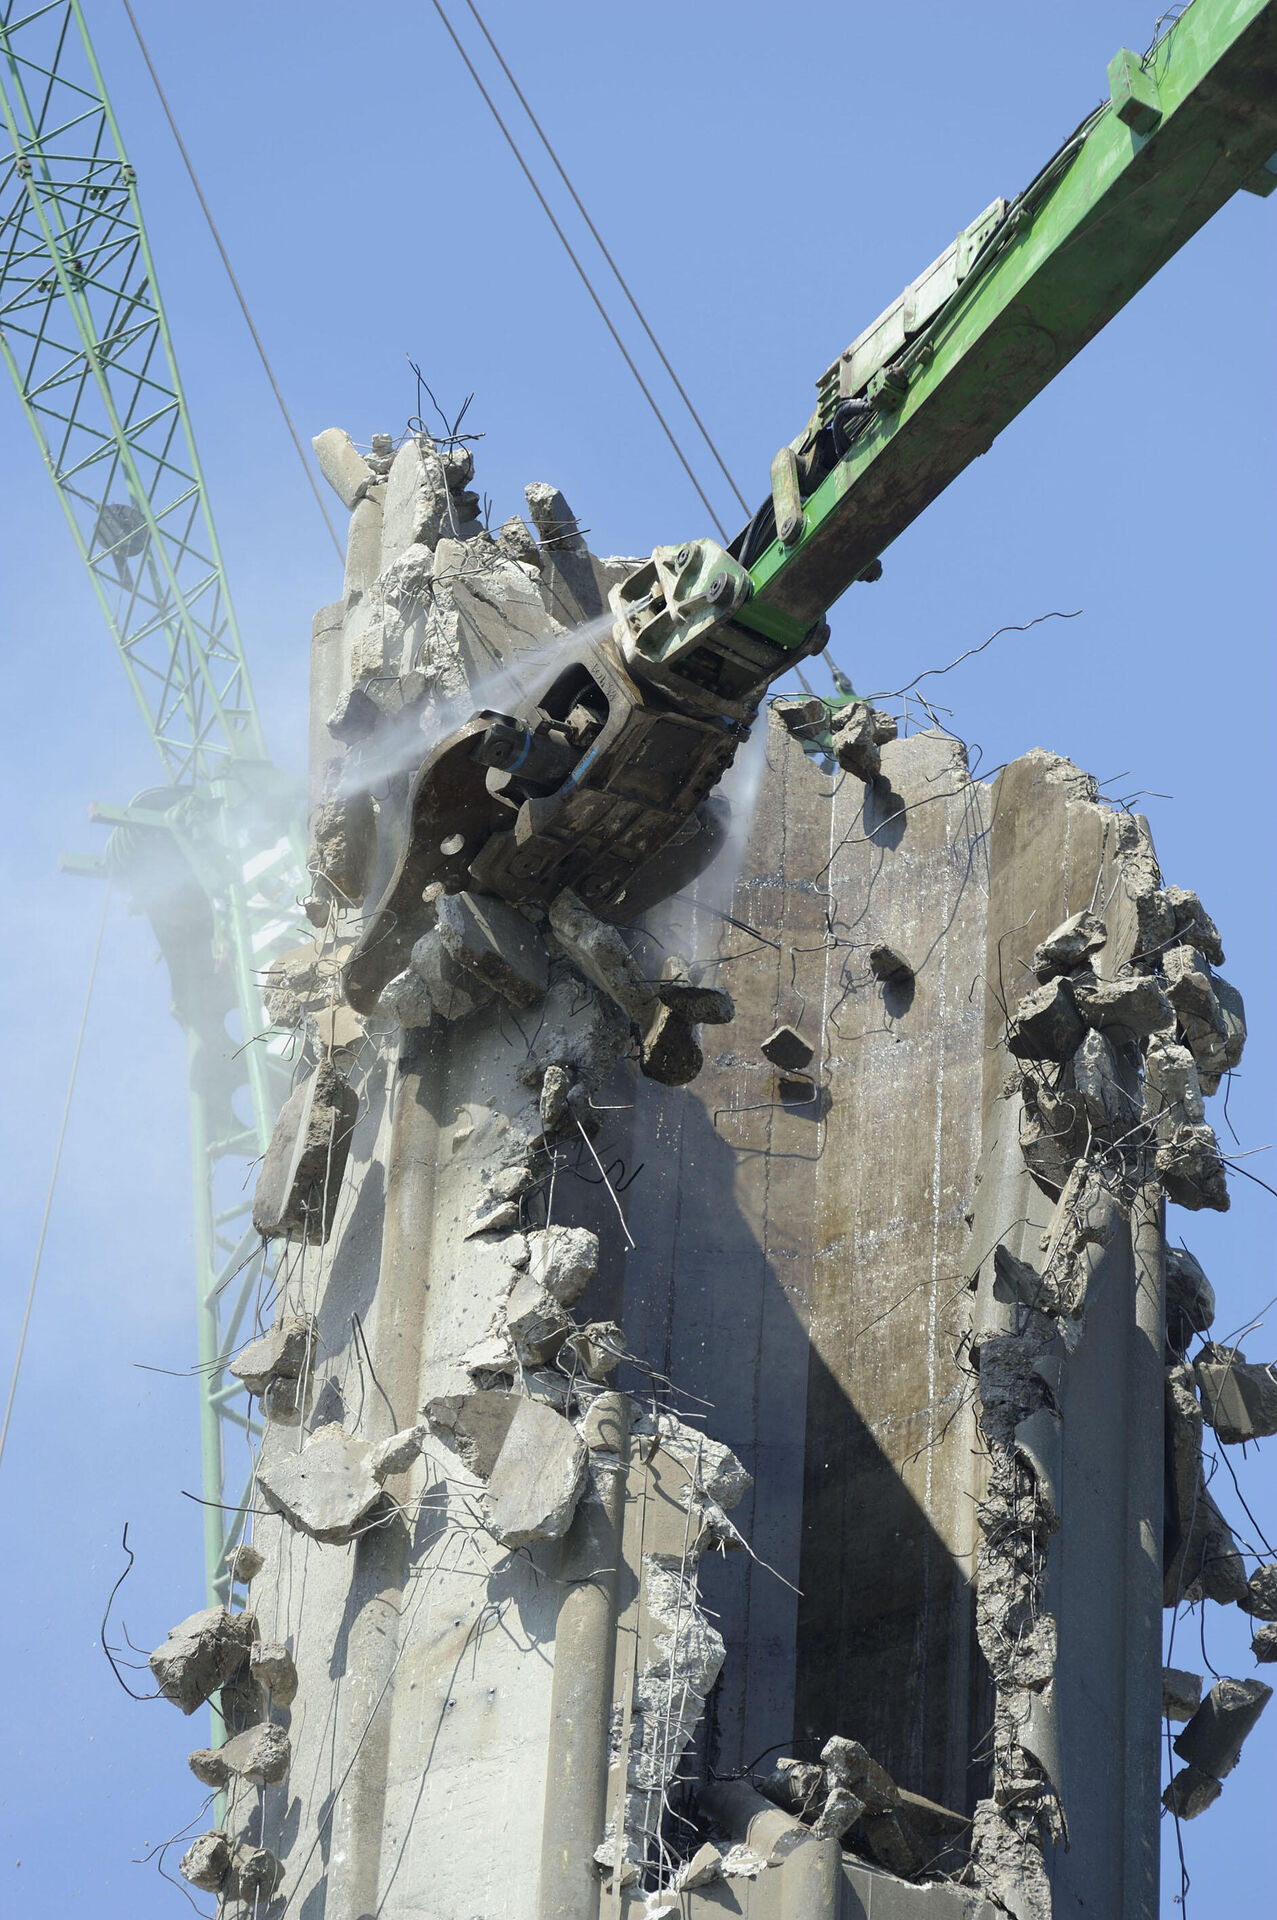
left=253, top=1060, right=359, bottom=1244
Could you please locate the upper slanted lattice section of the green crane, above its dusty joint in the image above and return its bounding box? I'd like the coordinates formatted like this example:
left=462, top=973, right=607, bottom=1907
left=0, top=0, right=265, bottom=781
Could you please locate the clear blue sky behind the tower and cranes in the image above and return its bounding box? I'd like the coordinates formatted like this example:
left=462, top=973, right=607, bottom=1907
left=0, top=0, right=1277, bottom=1920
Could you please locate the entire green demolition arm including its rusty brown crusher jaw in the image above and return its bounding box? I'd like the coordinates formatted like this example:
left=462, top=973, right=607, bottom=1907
left=346, top=0, right=1277, bottom=1012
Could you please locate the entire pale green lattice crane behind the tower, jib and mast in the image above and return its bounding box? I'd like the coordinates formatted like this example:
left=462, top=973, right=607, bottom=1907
left=0, top=0, right=303, bottom=1620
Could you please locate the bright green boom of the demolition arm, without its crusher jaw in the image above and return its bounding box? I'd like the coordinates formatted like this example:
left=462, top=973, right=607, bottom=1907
left=737, top=0, right=1277, bottom=629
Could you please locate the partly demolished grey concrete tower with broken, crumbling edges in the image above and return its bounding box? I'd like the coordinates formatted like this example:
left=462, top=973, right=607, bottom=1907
left=151, top=434, right=1241, bottom=1920
